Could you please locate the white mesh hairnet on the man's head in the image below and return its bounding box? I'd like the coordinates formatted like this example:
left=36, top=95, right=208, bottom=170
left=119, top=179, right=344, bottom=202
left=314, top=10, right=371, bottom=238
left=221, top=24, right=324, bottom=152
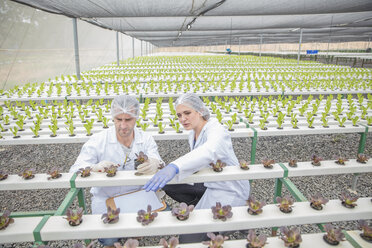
left=111, top=95, right=139, bottom=118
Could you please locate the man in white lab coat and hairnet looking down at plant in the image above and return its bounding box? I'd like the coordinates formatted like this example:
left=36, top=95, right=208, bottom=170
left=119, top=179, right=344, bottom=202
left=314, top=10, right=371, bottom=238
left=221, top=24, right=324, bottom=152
left=70, top=95, right=161, bottom=247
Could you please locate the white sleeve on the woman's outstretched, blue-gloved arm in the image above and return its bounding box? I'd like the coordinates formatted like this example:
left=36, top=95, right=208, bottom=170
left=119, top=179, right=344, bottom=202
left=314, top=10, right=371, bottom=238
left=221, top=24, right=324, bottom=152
left=172, top=126, right=231, bottom=181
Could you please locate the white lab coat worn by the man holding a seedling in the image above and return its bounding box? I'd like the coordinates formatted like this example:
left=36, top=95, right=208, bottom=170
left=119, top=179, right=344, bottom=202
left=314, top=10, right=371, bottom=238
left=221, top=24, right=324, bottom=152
left=70, top=126, right=161, bottom=214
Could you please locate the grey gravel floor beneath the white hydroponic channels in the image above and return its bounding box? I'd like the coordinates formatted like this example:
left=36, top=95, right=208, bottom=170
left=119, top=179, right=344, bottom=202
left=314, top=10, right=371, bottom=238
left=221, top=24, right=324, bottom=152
left=0, top=134, right=372, bottom=248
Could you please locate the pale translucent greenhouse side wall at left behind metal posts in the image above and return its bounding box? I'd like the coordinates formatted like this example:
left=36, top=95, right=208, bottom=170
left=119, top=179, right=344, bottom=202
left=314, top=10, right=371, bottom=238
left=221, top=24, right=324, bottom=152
left=0, top=0, right=145, bottom=89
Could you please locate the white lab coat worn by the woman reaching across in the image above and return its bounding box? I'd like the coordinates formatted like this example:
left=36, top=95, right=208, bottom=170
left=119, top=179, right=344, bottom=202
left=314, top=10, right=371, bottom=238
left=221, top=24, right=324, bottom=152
left=172, top=118, right=250, bottom=209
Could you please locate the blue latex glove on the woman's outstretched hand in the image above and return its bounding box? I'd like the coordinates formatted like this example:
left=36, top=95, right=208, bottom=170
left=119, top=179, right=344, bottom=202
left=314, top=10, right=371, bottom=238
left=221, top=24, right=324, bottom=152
left=142, top=164, right=179, bottom=192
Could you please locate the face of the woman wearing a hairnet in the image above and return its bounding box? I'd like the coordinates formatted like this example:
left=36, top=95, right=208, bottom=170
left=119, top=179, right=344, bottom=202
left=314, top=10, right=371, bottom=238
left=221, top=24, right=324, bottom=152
left=176, top=104, right=204, bottom=130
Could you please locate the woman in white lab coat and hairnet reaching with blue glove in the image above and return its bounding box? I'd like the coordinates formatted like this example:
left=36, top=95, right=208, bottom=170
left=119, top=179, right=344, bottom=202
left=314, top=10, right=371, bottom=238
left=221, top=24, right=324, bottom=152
left=144, top=93, right=250, bottom=240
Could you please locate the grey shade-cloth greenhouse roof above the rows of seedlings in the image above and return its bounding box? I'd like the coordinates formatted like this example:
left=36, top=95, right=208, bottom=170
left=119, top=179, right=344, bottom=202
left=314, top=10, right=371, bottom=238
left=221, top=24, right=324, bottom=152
left=13, top=0, right=372, bottom=47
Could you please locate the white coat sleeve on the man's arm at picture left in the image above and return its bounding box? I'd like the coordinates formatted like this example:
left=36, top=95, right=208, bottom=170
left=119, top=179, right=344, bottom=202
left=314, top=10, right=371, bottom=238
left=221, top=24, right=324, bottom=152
left=69, top=139, right=99, bottom=173
